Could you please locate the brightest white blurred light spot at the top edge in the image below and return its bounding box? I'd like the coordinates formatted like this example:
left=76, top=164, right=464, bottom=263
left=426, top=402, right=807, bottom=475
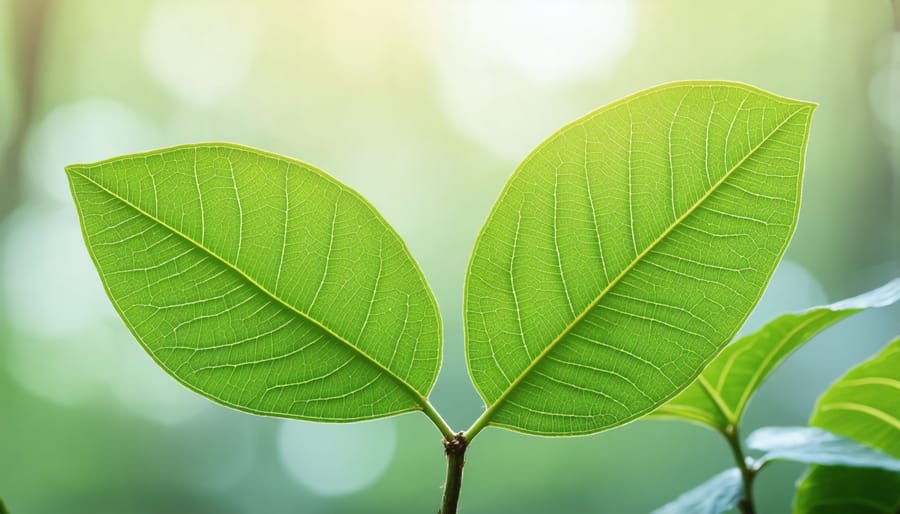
left=431, top=0, right=634, bottom=161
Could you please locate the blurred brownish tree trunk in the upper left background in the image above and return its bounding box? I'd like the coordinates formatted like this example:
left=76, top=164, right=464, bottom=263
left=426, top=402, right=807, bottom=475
left=0, top=0, right=54, bottom=219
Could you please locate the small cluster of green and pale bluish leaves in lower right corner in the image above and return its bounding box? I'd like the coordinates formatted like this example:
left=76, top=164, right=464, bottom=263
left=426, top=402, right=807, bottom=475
left=652, top=279, right=900, bottom=514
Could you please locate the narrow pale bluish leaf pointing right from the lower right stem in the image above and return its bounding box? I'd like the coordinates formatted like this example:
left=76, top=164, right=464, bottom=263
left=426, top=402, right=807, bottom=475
left=747, top=427, right=900, bottom=471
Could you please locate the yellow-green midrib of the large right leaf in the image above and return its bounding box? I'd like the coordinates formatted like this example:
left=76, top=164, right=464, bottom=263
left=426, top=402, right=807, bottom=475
left=466, top=105, right=811, bottom=440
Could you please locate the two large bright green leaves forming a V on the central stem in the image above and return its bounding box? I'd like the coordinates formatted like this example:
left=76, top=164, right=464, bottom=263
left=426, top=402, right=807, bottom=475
left=67, top=82, right=813, bottom=439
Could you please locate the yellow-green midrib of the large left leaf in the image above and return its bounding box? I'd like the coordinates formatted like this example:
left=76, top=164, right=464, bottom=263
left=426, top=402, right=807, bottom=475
left=66, top=166, right=430, bottom=410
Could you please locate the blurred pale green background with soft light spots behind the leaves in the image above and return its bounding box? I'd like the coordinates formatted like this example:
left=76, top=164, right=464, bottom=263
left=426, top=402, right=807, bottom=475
left=0, top=0, right=900, bottom=514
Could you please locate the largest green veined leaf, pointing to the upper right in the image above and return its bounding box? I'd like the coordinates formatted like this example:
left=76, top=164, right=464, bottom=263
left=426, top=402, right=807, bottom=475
left=465, top=82, right=814, bottom=437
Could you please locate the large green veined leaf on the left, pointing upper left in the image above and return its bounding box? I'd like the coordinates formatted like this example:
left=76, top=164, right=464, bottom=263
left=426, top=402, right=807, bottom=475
left=66, top=143, right=441, bottom=421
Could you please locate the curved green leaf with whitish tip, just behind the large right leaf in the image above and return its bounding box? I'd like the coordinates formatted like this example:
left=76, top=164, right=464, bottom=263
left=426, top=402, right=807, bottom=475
left=653, top=279, right=900, bottom=433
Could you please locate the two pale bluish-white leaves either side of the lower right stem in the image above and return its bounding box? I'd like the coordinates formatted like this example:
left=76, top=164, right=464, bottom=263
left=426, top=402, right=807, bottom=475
left=654, top=427, right=900, bottom=514
